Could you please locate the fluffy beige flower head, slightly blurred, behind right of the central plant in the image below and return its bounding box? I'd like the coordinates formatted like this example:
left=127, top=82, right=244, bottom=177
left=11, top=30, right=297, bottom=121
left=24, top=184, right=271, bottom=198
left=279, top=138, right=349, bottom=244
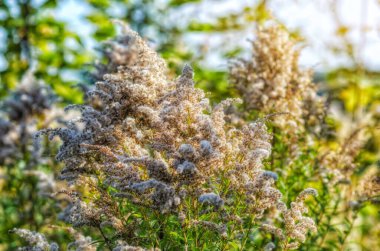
left=230, top=25, right=324, bottom=133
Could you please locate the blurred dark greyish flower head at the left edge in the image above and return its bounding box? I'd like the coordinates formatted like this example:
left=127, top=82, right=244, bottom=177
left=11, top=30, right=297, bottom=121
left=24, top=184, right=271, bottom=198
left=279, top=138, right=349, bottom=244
left=0, top=71, right=61, bottom=166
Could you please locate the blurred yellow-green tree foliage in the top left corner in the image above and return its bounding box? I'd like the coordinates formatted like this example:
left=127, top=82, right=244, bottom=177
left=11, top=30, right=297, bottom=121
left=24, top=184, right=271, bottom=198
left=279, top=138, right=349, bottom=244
left=0, top=0, right=89, bottom=102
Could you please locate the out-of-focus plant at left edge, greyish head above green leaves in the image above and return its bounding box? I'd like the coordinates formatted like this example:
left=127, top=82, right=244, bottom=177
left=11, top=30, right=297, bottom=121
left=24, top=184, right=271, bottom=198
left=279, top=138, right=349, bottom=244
left=0, top=72, right=73, bottom=249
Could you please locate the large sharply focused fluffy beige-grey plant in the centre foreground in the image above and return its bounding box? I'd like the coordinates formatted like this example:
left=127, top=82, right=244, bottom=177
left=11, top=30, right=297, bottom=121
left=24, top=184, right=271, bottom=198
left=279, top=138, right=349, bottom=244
left=31, top=24, right=316, bottom=250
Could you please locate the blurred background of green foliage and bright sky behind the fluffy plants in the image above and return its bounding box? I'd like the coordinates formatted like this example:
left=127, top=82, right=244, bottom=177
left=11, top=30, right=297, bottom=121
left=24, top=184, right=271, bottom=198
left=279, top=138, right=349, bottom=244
left=0, top=0, right=380, bottom=250
